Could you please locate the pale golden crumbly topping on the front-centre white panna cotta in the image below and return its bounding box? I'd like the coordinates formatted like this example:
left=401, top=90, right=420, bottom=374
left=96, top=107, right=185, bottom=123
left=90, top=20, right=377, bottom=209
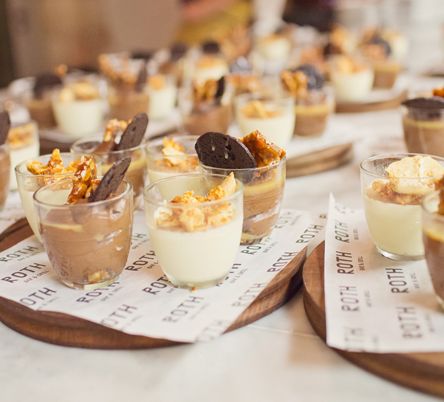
left=156, top=173, right=236, bottom=232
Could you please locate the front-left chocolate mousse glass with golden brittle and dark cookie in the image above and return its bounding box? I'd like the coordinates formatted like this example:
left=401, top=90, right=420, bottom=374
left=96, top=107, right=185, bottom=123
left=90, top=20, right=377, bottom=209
left=34, top=156, right=133, bottom=289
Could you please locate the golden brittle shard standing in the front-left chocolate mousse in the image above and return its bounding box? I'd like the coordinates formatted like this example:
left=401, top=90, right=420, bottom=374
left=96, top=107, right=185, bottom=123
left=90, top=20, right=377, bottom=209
left=68, top=156, right=100, bottom=204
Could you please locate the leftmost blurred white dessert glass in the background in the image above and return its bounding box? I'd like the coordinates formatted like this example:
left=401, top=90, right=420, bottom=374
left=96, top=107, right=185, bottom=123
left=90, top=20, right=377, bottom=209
left=52, top=81, right=105, bottom=139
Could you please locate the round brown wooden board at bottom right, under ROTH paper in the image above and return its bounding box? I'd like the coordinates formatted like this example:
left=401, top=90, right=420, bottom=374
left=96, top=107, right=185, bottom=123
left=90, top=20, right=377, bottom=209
left=303, top=243, right=444, bottom=397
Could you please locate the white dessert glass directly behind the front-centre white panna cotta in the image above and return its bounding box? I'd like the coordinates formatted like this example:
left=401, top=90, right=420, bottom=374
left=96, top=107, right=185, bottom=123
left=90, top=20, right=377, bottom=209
left=147, top=135, right=199, bottom=199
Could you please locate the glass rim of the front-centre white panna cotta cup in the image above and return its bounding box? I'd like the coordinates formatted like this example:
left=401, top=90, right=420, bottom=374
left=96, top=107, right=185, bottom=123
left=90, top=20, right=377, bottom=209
left=143, top=172, right=244, bottom=208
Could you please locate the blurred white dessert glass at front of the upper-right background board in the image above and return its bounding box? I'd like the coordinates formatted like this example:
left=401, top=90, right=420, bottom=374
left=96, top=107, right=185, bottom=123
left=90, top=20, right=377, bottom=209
left=329, top=55, right=374, bottom=102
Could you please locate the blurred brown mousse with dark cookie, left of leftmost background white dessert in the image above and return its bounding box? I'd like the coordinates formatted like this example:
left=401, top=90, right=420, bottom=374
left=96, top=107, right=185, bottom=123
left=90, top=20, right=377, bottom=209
left=26, top=73, right=62, bottom=128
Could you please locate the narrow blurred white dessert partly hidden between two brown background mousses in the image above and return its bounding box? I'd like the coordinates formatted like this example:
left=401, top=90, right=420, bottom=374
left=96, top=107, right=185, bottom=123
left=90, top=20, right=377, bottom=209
left=146, top=74, right=177, bottom=120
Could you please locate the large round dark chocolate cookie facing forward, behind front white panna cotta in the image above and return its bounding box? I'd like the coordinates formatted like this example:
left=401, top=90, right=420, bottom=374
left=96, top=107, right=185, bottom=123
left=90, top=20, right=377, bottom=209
left=195, top=132, right=256, bottom=169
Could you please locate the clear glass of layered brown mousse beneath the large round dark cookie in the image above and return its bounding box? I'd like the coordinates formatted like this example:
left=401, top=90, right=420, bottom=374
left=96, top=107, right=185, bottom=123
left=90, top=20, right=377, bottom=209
left=200, top=158, right=286, bottom=244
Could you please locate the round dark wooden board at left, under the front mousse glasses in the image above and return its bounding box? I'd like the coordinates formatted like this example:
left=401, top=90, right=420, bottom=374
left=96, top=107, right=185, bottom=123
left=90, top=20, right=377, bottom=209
left=0, top=219, right=305, bottom=349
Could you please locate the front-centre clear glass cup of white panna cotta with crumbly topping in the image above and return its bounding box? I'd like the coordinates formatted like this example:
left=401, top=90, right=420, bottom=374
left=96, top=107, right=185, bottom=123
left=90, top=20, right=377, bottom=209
left=144, top=174, right=243, bottom=289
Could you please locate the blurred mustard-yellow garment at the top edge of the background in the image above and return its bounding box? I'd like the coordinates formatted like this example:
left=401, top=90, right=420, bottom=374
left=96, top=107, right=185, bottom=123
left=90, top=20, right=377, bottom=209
left=177, top=0, right=251, bottom=45
